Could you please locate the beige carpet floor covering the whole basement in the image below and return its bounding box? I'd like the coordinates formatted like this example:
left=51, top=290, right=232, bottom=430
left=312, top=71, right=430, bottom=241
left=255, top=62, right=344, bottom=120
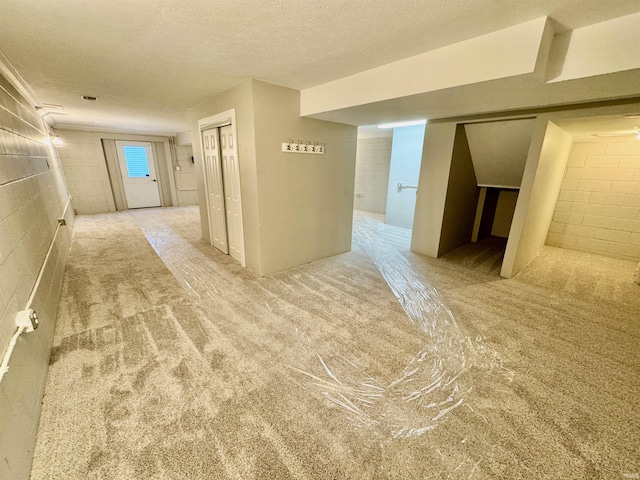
left=32, top=208, right=640, bottom=480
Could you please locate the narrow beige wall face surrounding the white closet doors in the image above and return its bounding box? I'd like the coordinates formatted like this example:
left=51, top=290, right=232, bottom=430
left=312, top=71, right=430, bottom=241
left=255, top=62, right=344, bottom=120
left=187, top=81, right=262, bottom=275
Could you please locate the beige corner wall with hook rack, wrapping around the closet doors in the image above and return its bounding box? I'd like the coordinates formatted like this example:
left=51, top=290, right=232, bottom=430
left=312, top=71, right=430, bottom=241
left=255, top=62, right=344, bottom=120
left=188, top=81, right=356, bottom=275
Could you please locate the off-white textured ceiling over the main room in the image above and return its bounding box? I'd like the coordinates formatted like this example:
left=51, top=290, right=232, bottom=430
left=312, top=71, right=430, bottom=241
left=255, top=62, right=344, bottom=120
left=0, top=0, right=638, bottom=132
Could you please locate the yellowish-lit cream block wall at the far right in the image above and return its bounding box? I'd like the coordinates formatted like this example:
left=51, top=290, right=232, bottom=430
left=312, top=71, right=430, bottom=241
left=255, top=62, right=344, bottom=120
left=546, top=136, right=640, bottom=262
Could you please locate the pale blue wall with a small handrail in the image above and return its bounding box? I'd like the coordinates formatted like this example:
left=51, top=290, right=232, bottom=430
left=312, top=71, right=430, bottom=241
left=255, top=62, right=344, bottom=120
left=385, top=125, right=425, bottom=229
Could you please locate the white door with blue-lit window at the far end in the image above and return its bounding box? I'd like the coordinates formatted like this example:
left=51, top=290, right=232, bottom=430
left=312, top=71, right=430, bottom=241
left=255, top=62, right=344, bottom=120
left=116, top=140, right=160, bottom=208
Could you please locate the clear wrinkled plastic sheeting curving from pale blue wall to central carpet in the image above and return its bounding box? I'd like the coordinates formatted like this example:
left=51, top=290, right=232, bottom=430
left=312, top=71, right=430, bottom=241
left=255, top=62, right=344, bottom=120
left=294, top=217, right=508, bottom=438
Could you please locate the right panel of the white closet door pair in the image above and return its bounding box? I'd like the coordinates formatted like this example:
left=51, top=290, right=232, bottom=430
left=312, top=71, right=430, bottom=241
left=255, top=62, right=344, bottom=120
left=220, top=125, right=244, bottom=265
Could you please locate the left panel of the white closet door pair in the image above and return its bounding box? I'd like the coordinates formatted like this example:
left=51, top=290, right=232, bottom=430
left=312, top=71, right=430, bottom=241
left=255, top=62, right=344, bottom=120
left=202, top=128, right=229, bottom=253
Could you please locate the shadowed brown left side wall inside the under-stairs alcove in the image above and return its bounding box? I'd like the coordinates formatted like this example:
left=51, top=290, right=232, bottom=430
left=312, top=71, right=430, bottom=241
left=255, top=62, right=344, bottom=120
left=438, top=125, right=480, bottom=256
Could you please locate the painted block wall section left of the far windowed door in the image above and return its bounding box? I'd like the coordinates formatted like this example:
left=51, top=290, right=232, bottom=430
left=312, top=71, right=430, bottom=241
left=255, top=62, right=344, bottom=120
left=56, top=130, right=115, bottom=214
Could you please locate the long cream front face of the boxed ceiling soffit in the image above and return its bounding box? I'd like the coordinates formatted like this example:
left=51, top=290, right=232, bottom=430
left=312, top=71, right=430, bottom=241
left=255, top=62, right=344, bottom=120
left=301, top=17, right=551, bottom=115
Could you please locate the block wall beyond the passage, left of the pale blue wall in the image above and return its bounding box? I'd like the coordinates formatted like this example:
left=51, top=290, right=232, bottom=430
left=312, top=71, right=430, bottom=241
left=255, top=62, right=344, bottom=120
left=353, top=136, right=392, bottom=214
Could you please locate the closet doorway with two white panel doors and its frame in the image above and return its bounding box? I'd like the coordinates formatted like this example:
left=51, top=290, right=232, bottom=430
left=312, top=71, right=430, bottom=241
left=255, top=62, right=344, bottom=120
left=198, top=110, right=245, bottom=266
